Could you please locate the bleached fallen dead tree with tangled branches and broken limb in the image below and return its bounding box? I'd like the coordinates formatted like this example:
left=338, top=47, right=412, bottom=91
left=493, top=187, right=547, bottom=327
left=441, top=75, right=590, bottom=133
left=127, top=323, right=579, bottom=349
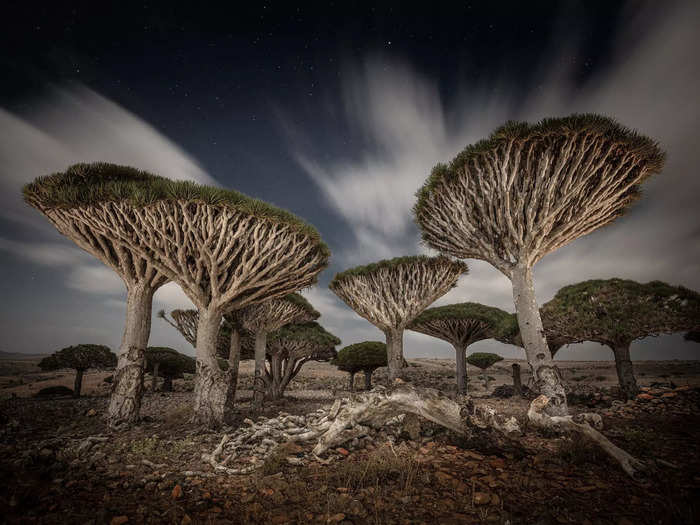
left=202, top=382, right=644, bottom=477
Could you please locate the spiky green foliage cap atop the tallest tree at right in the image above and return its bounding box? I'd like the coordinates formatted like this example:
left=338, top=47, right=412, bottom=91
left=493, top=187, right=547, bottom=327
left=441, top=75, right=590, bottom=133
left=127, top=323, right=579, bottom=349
left=414, top=114, right=666, bottom=220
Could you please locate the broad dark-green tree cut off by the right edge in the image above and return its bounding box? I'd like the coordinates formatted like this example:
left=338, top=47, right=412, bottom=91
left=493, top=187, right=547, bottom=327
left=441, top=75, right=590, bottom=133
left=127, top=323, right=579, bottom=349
left=542, top=279, right=700, bottom=398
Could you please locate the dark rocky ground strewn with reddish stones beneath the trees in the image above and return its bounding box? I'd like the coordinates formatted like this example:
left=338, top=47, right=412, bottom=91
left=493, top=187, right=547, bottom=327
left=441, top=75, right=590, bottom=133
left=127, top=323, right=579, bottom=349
left=0, top=362, right=700, bottom=525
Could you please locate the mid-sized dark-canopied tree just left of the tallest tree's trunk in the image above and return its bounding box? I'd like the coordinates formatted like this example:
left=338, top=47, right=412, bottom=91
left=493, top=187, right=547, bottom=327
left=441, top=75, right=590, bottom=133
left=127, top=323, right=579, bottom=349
left=408, top=303, right=517, bottom=394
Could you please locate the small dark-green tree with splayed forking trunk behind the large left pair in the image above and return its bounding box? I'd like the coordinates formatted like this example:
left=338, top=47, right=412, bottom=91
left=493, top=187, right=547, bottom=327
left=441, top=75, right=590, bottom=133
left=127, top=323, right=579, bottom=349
left=263, top=321, right=340, bottom=399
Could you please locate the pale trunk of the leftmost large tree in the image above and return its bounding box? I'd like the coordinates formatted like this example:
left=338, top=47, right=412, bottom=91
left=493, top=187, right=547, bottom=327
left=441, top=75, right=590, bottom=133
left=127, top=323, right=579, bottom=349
left=107, top=284, right=154, bottom=428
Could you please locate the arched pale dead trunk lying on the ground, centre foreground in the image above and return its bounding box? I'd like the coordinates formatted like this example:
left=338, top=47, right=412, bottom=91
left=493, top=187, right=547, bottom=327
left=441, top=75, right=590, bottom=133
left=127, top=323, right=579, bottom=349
left=313, top=383, right=520, bottom=456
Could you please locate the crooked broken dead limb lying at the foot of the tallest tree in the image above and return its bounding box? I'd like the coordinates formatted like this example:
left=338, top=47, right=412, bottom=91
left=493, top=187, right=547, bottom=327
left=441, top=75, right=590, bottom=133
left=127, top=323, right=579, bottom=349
left=527, top=395, right=646, bottom=478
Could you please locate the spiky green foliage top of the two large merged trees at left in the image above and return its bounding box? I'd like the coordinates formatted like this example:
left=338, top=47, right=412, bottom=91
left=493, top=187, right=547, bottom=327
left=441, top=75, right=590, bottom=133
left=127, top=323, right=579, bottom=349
left=22, top=162, right=330, bottom=255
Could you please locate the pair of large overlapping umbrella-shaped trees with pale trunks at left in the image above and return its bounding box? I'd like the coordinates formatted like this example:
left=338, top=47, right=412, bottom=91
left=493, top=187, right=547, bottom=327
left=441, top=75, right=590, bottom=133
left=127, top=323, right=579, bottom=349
left=23, top=163, right=330, bottom=427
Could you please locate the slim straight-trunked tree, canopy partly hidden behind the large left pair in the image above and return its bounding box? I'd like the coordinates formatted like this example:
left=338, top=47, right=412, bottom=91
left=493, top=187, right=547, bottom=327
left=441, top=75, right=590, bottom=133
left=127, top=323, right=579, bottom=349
left=236, top=293, right=321, bottom=410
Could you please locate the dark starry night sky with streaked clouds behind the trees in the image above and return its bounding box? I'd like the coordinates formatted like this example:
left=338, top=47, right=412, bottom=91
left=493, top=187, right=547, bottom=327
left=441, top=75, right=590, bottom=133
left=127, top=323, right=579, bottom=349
left=0, top=1, right=700, bottom=359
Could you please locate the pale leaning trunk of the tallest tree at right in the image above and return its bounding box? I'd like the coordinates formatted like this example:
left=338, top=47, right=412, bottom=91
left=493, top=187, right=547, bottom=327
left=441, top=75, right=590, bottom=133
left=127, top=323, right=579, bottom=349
left=511, top=264, right=569, bottom=416
